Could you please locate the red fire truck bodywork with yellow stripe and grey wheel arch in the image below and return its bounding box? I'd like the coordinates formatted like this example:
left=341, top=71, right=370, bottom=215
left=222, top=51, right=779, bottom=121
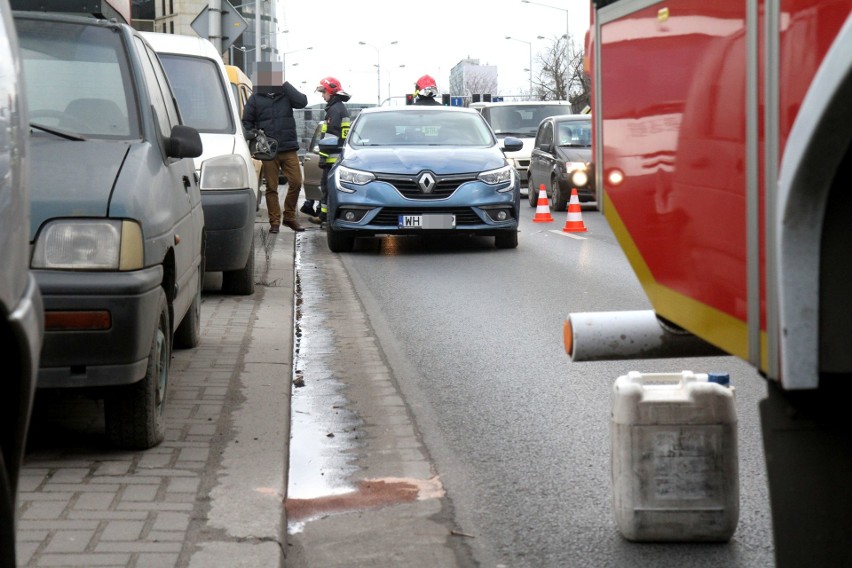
left=574, top=0, right=852, bottom=389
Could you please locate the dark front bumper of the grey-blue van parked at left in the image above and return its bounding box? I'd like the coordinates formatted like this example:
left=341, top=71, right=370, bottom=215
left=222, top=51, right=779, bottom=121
left=33, top=265, right=163, bottom=388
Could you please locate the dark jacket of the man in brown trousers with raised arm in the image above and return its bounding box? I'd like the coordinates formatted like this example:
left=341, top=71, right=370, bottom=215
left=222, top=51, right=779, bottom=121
left=243, top=82, right=308, bottom=152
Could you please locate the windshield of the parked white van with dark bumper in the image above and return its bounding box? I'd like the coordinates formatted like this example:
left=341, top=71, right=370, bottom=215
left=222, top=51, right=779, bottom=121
left=159, top=53, right=234, bottom=134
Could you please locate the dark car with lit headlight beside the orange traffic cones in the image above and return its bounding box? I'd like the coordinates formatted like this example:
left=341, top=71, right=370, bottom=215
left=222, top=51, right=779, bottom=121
left=529, top=114, right=597, bottom=211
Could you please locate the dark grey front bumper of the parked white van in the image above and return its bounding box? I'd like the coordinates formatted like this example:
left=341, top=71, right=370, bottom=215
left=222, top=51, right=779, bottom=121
left=201, top=188, right=257, bottom=272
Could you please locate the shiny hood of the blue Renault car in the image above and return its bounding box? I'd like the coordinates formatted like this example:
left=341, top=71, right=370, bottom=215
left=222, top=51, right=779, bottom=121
left=341, top=146, right=506, bottom=175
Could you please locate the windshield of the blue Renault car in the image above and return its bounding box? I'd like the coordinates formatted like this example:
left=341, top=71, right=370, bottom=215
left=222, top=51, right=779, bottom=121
left=348, top=110, right=495, bottom=146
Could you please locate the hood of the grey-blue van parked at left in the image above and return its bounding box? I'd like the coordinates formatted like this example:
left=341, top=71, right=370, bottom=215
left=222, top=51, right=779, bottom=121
left=30, top=137, right=130, bottom=240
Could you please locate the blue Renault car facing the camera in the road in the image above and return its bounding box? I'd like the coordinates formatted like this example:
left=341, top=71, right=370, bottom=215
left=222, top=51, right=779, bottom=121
left=320, top=105, right=522, bottom=252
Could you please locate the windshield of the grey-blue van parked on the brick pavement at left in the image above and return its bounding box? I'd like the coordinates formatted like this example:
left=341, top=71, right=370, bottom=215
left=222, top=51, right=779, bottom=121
left=16, top=18, right=139, bottom=139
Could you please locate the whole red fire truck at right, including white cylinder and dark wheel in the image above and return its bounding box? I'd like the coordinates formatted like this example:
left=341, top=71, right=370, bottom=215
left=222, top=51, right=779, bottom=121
left=564, top=0, right=852, bottom=566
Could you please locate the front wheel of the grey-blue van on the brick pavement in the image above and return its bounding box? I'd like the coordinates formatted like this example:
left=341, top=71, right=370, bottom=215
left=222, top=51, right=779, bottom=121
left=104, top=289, right=172, bottom=450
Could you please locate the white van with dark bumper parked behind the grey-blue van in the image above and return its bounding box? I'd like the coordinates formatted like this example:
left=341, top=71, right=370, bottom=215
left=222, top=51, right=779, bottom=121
left=142, top=32, right=258, bottom=295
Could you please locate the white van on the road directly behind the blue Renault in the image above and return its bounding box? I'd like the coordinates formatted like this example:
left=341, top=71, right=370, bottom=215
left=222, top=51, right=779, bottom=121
left=470, top=101, right=573, bottom=193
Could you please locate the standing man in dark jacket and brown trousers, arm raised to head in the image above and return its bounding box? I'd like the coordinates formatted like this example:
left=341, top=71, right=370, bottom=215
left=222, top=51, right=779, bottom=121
left=243, top=61, right=308, bottom=233
